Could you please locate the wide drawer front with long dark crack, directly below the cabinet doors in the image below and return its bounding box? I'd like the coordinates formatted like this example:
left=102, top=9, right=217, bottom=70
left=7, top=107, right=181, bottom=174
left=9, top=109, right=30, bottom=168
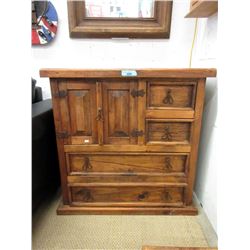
left=67, top=153, right=188, bottom=176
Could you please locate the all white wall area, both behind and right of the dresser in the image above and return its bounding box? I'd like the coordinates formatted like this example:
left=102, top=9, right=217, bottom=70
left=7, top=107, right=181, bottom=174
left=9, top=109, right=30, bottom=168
left=32, top=0, right=217, bottom=232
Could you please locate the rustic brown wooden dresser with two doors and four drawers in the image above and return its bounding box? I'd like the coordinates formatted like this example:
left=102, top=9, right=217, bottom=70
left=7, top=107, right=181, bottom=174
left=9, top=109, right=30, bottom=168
left=40, top=69, right=216, bottom=215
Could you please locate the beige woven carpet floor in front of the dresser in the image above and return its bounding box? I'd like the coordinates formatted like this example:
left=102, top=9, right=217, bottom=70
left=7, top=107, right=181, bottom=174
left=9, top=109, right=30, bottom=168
left=32, top=191, right=215, bottom=250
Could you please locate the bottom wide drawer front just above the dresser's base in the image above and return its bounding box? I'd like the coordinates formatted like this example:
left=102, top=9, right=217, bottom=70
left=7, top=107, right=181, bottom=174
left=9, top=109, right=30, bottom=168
left=70, top=186, right=184, bottom=205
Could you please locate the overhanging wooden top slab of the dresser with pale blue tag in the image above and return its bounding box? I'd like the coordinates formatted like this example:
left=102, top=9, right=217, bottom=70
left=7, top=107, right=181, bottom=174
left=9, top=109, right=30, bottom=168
left=40, top=68, right=217, bottom=79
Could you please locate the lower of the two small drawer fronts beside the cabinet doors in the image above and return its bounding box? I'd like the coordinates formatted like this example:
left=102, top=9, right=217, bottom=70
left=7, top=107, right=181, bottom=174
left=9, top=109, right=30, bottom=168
left=146, top=120, right=192, bottom=144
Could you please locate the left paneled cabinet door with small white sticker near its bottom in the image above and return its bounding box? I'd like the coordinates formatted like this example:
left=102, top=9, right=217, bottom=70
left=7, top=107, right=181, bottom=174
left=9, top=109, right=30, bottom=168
left=58, top=80, right=98, bottom=145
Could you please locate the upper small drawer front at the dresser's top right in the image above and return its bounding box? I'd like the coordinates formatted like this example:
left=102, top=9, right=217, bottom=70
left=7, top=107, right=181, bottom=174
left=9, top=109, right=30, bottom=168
left=147, top=81, right=196, bottom=109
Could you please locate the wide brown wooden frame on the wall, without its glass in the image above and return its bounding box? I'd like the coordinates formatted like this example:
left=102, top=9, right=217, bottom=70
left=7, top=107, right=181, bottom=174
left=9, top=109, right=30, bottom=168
left=68, top=1, right=172, bottom=38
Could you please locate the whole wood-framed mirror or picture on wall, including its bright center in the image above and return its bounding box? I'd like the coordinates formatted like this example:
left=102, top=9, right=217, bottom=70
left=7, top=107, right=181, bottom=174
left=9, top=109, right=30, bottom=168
left=68, top=0, right=172, bottom=38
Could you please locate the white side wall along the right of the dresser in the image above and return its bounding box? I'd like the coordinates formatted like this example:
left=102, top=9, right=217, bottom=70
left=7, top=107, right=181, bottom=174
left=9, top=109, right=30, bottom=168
left=192, top=14, right=218, bottom=232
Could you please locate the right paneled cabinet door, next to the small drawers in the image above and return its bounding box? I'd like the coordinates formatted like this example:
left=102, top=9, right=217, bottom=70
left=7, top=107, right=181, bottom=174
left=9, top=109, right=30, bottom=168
left=102, top=80, right=140, bottom=144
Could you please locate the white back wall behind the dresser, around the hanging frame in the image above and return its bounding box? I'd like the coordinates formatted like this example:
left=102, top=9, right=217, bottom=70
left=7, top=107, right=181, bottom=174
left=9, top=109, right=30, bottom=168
left=32, top=0, right=194, bottom=98
